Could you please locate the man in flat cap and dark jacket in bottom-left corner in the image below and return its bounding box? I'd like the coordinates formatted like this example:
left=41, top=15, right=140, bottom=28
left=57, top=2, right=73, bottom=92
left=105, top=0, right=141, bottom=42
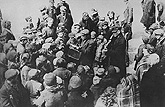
left=0, top=69, right=30, bottom=107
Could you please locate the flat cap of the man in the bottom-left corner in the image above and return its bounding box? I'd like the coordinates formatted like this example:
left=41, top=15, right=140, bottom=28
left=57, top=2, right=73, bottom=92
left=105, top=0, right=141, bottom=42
left=5, top=69, right=19, bottom=79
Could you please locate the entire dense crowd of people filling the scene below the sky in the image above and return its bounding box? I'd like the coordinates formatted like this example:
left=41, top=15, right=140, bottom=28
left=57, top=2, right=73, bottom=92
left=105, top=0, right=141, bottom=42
left=0, top=0, right=165, bottom=107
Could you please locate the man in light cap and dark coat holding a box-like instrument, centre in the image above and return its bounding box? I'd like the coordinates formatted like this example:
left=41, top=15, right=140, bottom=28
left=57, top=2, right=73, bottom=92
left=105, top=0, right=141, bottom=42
left=79, top=29, right=95, bottom=67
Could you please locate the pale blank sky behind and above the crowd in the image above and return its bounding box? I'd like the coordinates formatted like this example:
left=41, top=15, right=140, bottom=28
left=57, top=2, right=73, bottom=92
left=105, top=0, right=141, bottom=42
left=0, top=0, right=164, bottom=37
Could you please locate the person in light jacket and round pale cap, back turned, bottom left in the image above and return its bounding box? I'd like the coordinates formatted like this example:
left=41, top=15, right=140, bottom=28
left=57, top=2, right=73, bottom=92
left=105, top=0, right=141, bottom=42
left=34, top=73, right=66, bottom=107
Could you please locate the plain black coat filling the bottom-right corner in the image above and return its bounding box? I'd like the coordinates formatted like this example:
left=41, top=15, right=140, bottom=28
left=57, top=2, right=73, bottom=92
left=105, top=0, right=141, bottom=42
left=140, top=64, right=165, bottom=107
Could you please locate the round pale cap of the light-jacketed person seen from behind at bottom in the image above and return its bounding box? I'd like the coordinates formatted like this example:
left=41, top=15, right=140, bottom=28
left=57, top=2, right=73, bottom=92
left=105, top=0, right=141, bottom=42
left=43, top=73, right=57, bottom=86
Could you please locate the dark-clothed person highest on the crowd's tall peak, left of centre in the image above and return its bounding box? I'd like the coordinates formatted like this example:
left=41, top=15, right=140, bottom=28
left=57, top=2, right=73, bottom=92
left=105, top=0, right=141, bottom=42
left=57, top=6, right=73, bottom=33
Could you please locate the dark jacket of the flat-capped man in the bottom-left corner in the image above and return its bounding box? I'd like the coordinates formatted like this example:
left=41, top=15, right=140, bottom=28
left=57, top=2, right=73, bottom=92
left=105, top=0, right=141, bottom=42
left=0, top=81, right=30, bottom=107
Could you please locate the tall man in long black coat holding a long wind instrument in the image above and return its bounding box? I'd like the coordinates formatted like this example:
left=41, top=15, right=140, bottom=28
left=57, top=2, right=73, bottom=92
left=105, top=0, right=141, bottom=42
left=107, top=27, right=126, bottom=77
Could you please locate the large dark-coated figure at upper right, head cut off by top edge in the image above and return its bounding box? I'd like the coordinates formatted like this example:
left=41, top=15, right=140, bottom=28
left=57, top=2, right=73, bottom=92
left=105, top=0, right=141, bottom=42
left=140, top=0, right=156, bottom=30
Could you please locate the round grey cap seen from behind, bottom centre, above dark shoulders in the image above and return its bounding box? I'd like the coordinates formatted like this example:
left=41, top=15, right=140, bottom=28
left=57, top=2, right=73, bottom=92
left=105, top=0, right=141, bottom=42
left=69, top=76, right=82, bottom=88
